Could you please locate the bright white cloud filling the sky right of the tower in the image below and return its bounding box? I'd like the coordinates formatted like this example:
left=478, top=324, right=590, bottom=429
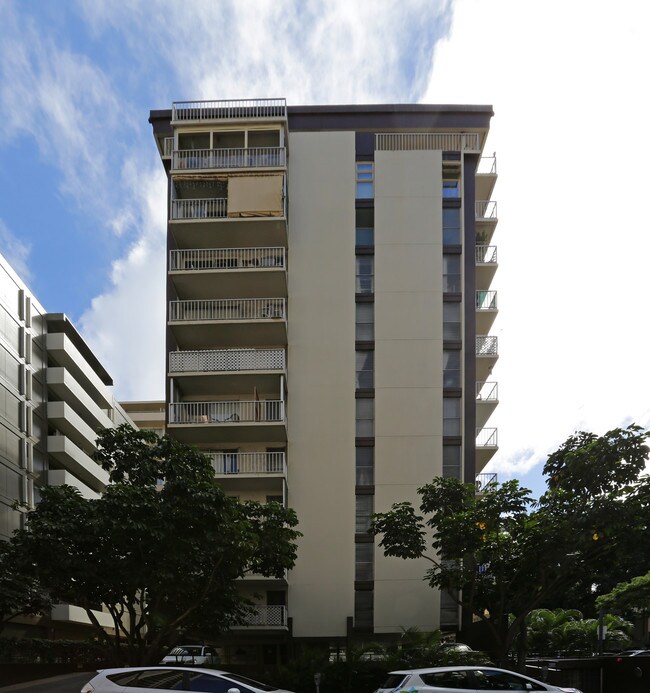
left=423, top=0, right=650, bottom=474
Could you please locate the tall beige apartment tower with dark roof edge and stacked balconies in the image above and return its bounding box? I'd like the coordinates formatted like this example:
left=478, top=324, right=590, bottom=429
left=150, top=99, right=498, bottom=662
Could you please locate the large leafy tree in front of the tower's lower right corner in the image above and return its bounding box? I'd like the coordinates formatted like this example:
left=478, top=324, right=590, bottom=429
left=372, top=425, right=650, bottom=662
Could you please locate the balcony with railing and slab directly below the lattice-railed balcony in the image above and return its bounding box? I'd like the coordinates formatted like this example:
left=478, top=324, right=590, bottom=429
left=169, top=399, right=287, bottom=445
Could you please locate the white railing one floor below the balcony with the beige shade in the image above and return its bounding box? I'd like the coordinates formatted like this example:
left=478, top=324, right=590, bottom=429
left=169, top=247, right=285, bottom=272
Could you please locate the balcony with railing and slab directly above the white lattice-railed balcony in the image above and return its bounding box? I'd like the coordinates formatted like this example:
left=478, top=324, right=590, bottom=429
left=169, top=298, right=287, bottom=349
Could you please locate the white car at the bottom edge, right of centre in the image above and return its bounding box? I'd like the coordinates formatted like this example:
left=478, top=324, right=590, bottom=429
left=375, top=666, right=580, bottom=693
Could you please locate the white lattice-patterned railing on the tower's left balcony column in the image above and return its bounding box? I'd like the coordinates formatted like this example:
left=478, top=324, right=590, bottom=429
left=169, top=349, right=285, bottom=373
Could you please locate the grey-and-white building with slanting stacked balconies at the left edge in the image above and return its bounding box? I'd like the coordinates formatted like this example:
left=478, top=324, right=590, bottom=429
left=0, top=256, right=132, bottom=638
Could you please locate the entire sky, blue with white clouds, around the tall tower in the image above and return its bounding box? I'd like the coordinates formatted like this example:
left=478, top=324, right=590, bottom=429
left=0, top=0, right=650, bottom=493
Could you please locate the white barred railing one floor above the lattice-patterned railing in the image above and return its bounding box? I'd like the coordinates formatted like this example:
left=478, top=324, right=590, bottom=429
left=169, top=298, right=286, bottom=322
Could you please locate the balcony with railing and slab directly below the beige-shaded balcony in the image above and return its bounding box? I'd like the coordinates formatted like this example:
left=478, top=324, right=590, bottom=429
left=169, top=246, right=287, bottom=299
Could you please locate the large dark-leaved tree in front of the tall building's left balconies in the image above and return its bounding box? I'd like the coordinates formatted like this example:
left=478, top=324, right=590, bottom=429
left=12, top=426, right=299, bottom=664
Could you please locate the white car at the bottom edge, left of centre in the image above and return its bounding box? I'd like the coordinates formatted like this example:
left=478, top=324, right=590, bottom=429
left=81, top=666, right=291, bottom=693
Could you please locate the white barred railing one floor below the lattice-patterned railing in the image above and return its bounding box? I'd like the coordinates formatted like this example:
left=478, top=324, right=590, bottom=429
left=169, top=399, right=284, bottom=424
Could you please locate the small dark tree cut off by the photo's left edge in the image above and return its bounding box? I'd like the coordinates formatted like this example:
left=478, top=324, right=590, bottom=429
left=0, top=541, right=51, bottom=632
